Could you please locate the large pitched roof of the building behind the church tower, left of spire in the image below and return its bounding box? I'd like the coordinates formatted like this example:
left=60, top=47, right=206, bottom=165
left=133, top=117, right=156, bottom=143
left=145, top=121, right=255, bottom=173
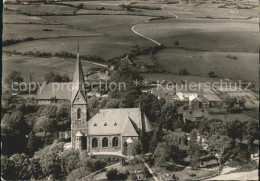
left=36, top=82, right=71, bottom=100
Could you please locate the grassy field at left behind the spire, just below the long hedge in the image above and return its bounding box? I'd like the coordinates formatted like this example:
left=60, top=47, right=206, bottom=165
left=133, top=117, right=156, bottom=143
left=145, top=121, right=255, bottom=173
left=2, top=55, right=103, bottom=82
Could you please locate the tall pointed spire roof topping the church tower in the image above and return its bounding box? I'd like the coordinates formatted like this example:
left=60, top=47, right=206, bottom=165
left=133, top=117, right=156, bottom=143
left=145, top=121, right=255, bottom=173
left=71, top=43, right=86, bottom=102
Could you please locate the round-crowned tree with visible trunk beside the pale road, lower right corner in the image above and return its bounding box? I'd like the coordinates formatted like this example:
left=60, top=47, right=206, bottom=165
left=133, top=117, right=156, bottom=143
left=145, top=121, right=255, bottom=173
left=208, top=135, right=233, bottom=173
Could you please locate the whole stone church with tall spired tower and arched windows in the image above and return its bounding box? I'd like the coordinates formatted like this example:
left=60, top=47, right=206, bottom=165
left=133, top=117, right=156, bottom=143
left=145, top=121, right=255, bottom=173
left=71, top=53, right=153, bottom=154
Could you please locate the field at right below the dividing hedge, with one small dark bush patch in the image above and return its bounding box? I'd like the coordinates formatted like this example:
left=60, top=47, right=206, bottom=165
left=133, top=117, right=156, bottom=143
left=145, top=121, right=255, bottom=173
left=156, top=48, right=259, bottom=85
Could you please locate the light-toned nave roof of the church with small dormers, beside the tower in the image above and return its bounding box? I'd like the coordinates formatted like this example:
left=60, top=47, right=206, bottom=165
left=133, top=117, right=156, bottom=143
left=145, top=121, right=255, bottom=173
left=88, top=108, right=150, bottom=136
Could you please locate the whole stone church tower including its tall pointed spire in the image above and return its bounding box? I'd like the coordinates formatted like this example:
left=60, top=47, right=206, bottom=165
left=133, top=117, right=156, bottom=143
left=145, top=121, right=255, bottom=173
left=71, top=45, right=88, bottom=149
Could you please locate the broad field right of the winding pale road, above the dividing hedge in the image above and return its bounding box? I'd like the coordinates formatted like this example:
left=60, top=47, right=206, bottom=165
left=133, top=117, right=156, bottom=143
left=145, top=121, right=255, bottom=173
left=136, top=18, right=259, bottom=52
